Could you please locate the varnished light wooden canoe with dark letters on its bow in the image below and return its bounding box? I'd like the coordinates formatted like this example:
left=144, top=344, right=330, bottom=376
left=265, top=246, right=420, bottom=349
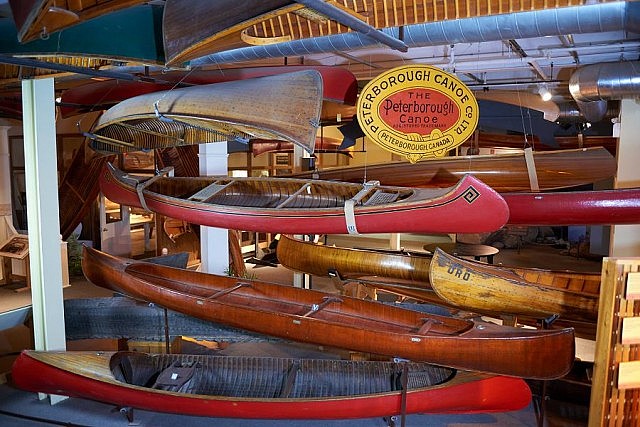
left=429, top=248, right=600, bottom=322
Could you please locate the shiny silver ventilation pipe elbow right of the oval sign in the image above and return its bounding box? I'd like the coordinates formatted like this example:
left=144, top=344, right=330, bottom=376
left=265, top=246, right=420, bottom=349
left=569, top=61, right=640, bottom=122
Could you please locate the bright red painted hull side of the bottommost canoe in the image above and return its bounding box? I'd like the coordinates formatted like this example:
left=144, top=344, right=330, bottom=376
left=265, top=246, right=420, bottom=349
left=12, top=351, right=531, bottom=419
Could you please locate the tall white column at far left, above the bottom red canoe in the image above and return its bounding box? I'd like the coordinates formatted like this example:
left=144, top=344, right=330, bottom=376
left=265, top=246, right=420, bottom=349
left=22, top=79, right=66, bottom=403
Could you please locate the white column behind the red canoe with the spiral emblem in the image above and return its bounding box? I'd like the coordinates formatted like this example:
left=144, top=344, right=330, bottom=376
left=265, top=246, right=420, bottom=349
left=199, top=142, right=229, bottom=274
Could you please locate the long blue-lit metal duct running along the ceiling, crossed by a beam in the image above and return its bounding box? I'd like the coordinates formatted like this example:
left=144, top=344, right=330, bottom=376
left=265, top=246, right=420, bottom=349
left=190, top=1, right=640, bottom=67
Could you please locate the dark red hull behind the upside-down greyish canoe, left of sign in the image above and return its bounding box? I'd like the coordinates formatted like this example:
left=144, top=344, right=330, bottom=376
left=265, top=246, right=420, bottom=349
left=60, top=65, right=358, bottom=117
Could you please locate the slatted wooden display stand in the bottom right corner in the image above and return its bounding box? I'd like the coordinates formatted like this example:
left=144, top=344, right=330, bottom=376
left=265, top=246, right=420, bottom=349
left=589, top=258, right=640, bottom=427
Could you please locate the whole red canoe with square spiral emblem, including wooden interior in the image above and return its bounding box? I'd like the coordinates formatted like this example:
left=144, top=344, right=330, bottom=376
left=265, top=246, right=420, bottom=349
left=100, top=166, right=508, bottom=234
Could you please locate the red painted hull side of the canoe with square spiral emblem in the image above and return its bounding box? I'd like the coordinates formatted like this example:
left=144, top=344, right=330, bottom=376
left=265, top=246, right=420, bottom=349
left=100, top=168, right=509, bottom=234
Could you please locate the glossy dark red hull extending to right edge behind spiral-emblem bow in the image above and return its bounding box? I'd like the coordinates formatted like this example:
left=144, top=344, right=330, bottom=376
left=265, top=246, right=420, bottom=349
left=503, top=188, right=640, bottom=225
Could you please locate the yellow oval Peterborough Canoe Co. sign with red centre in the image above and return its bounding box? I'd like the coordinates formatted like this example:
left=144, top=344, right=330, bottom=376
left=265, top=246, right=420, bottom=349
left=357, top=65, right=478, bottom=163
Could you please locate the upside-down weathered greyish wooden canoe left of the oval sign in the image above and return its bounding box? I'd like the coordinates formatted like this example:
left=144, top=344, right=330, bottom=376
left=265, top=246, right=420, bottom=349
left=92, top=70, right=322, bottom=152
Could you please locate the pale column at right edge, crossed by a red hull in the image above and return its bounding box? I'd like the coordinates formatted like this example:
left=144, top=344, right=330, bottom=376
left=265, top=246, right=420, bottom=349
left=609, top=99, right=640, bottom=257
